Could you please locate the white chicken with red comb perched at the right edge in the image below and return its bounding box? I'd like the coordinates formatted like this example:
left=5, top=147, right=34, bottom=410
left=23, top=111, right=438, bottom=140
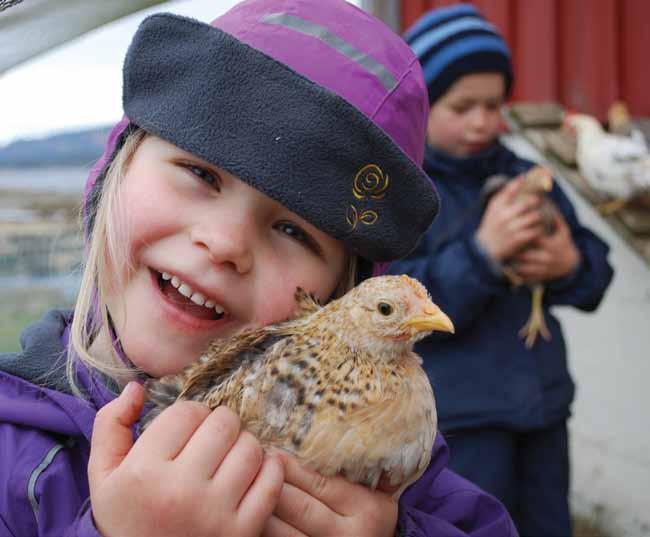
left=564, top=114, right=650, bottom=214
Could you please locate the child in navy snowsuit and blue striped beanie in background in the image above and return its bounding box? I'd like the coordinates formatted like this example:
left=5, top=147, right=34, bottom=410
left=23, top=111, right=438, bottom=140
left=391, top=3, right=612, bottom=537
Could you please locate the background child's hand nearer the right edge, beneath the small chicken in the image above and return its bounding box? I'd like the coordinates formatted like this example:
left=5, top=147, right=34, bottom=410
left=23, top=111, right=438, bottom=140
left=514, top=209, right=580, bottom=283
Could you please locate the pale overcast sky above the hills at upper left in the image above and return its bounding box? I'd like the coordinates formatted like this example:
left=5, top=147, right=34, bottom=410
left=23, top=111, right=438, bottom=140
left=0, top=0, right=358, bottom=145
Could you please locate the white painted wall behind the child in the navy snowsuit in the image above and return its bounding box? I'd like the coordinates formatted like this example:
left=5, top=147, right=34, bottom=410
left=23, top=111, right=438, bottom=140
left=504, top=136, right=650, bottom=537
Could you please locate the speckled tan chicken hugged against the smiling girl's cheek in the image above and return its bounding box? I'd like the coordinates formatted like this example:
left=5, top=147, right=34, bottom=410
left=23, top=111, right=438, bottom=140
left=140, top=276, right=453, bottom=492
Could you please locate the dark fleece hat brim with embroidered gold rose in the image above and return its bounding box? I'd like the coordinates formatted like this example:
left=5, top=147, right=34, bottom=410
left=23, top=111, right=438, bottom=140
left=124, top=14, right=438, bottom=261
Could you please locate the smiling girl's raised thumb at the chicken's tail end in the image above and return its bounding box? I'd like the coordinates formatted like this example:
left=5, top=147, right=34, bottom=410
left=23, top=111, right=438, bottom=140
left=88, top=381, right=144, bottom=488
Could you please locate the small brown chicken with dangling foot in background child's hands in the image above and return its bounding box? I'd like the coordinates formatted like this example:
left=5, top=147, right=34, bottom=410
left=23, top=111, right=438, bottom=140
left=482, top=166, right=555, bottom=349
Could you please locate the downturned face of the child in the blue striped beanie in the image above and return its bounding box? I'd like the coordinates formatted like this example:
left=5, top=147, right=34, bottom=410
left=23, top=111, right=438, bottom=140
left=427, top=73, right=505, bottom=157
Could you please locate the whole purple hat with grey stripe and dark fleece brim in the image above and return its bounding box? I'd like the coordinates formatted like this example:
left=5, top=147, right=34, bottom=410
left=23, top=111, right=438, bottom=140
left=86, top=0, right=438, bottom=268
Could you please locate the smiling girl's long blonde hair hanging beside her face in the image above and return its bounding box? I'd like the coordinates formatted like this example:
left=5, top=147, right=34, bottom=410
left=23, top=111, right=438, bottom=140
left=67, top=129, right=358, bottom=397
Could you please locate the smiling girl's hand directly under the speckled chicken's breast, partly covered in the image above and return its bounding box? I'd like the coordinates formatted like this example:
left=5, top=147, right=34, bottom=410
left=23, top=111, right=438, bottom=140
left=262, top=454, right=397, bottom=537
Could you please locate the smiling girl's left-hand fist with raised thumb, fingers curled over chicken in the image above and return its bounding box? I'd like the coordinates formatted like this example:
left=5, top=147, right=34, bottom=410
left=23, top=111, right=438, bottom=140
left=88, top=382, right=284, bottom=537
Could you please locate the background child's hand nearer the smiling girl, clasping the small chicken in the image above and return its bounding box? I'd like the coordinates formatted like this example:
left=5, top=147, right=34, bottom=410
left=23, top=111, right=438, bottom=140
left=476, top=178, right=544, bottom=262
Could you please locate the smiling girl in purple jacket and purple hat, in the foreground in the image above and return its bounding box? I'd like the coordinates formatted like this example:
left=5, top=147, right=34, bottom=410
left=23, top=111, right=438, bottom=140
left=0, top=0, right=515, bottom=537
